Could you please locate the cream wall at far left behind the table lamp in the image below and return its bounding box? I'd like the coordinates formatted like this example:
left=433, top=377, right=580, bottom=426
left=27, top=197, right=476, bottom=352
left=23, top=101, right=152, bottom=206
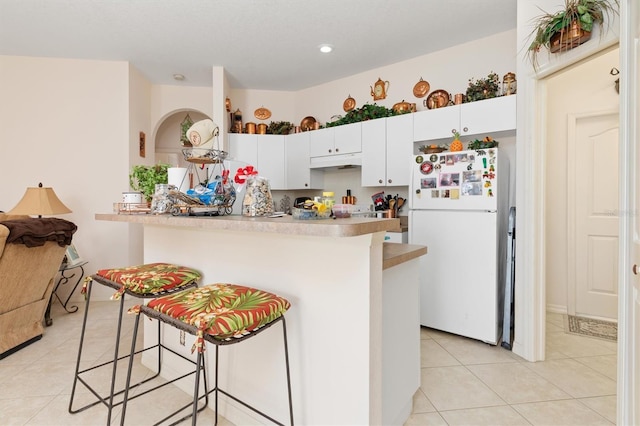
left=0, top=56, right=130, bottom=300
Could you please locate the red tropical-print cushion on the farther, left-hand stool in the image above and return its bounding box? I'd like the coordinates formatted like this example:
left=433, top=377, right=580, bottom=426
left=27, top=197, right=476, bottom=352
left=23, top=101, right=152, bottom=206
left=83, top=263, right=201, bottom=299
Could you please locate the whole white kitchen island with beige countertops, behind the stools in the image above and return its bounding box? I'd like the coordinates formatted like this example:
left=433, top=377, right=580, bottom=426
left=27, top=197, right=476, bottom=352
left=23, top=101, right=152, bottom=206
left=96, top=214, right=426, bottom=425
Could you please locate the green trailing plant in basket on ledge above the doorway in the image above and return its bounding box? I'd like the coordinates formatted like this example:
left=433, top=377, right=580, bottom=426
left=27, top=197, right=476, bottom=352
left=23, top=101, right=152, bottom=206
left=527, top=0, right=619, bottom=69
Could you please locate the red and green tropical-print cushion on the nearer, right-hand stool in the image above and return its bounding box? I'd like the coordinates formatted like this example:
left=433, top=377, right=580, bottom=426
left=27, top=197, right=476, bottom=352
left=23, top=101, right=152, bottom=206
left=136, top=283, right=291, bottom=351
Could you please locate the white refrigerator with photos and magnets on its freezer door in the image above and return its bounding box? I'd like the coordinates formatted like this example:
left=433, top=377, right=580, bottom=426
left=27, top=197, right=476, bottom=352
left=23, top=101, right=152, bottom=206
left=408, top=148, right=509, bottom=345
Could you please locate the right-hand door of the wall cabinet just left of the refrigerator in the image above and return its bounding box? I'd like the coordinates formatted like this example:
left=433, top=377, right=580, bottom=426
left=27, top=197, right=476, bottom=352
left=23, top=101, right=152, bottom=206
left=386, top=114, right=414, bottom=186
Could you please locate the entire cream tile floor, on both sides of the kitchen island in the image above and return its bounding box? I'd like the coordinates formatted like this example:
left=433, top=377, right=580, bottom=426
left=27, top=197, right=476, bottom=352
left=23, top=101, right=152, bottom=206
left=0, top=302, right=616, bottom=426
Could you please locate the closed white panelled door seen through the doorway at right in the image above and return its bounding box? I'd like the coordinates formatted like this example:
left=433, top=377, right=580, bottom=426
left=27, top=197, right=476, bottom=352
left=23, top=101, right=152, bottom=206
left=567, top=111, right=619, bottom=320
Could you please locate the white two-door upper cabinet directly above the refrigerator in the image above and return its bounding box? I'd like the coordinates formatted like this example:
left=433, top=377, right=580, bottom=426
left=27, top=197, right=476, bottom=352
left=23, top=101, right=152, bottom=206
left=413, top=95, right=516, bottom=141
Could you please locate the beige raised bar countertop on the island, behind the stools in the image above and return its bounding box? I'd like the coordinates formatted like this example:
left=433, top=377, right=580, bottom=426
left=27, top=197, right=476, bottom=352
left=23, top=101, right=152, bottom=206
left=95, top=213, right=400, bottom=237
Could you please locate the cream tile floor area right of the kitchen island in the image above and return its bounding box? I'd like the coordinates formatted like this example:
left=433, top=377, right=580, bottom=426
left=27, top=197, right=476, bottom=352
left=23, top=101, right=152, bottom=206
left=406, top=314, right=617, bottom=425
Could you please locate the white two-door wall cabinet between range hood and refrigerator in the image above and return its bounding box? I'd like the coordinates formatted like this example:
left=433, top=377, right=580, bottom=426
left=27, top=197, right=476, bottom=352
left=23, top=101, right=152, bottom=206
left=361, top=114, right=414, bottom=186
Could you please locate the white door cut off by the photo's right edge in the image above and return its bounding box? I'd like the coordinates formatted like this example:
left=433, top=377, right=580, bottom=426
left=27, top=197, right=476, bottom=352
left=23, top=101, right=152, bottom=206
left=617, top=0, right=640, bottom=425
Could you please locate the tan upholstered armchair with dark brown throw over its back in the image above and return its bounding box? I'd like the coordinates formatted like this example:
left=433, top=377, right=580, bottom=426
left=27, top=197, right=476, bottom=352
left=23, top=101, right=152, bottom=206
left=0, top=213, right=76, bottom=359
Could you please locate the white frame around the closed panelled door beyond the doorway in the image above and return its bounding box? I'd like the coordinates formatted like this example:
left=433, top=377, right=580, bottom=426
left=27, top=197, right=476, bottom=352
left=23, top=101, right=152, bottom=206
left=567, top=109, right=621, bottom=315
